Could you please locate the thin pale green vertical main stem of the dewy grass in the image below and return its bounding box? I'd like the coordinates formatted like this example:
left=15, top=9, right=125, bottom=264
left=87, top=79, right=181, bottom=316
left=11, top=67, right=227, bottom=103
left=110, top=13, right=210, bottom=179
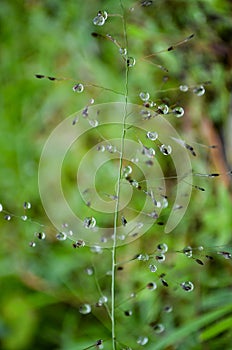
left=111, top=0, right=129, bottom=350
